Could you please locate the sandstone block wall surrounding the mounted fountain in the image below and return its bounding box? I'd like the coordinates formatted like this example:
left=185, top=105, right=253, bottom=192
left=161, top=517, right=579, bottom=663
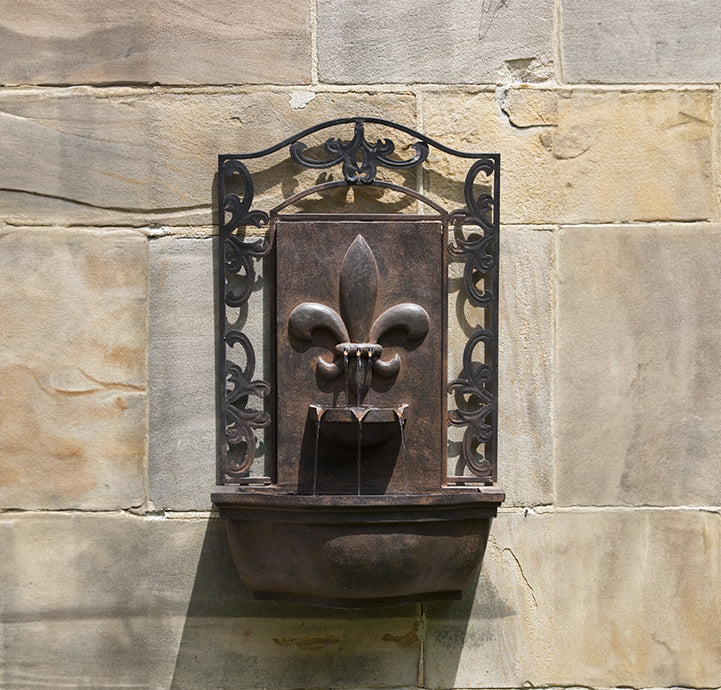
left=0, top=0, right=721, bottom=690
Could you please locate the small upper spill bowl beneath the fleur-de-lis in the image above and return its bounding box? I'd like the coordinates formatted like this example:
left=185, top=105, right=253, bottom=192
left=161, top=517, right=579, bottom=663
left=308, top=405, right=408, bottom=448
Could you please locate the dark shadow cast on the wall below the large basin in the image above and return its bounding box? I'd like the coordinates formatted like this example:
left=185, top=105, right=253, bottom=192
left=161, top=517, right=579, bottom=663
left=171, top=518, right=514, bottom=690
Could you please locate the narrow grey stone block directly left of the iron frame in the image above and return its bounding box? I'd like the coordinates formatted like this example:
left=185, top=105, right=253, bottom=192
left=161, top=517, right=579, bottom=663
left=148, top=237, right=218, bottom=510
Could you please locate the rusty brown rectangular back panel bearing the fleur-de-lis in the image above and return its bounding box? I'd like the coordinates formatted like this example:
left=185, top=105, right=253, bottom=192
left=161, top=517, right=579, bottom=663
left=274, top=216, right=447, bottom=494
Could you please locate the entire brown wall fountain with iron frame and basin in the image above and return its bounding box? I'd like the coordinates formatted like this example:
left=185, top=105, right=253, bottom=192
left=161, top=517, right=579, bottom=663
left=212, top=118, right=504, bottom=607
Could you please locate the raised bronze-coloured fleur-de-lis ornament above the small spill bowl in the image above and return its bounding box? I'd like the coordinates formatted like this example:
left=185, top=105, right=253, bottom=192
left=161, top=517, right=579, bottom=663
left=288, top=235, right=430, bottom=405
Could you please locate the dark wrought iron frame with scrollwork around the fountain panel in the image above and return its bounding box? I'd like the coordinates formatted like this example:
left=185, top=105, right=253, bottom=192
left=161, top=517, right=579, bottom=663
left=218, top=117, right=500, bottom=485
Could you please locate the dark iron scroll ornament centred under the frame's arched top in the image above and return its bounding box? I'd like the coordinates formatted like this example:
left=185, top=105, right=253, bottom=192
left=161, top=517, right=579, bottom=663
left=290, top=120, right=428, bottom=184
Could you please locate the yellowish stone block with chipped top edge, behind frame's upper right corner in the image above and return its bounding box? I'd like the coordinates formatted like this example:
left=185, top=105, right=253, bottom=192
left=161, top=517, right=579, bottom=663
left=423, top=89, right=715, bottom=224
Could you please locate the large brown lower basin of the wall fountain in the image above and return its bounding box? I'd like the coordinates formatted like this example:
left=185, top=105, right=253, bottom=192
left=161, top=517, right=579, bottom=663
left=212, top=486, right=504, bottom=608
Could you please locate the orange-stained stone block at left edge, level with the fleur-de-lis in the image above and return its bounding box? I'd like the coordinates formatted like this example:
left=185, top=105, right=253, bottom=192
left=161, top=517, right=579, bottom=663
left=0, top=229, right=147, bottom=509
